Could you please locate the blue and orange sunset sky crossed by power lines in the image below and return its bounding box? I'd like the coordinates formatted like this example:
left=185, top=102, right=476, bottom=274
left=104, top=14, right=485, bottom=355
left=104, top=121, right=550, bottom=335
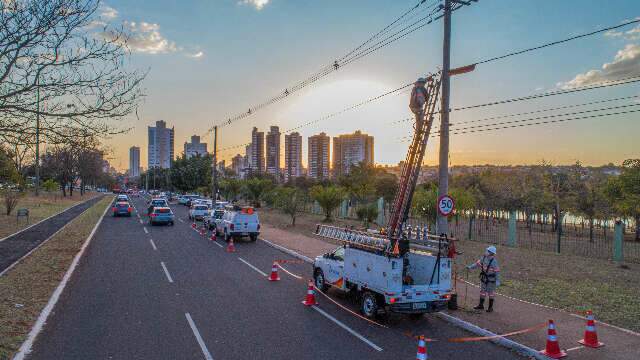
left=99, top=0, right=640, bottom=170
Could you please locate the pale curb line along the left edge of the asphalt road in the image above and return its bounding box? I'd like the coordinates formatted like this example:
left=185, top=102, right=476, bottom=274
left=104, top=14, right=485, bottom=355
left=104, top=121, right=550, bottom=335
left=13, top=198, right=111, bottom=360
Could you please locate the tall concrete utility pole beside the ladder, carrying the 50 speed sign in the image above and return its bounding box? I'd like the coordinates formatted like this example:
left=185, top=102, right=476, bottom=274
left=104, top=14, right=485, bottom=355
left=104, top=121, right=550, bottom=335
left=436, top=0, right=452, bottom=235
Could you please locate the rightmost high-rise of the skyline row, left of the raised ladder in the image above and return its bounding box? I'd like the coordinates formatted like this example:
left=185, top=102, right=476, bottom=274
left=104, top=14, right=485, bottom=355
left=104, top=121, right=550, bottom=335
left=332, top=130, right=374, bottom=177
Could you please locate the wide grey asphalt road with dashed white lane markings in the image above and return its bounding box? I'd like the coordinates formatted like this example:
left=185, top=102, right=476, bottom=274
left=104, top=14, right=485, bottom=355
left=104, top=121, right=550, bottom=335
left=30, top=199, right=520, bottom=360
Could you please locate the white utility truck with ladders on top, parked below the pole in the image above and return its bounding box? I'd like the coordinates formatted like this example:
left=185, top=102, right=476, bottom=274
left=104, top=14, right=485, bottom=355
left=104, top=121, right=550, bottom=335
left=313, top=225, right=452, bottom=318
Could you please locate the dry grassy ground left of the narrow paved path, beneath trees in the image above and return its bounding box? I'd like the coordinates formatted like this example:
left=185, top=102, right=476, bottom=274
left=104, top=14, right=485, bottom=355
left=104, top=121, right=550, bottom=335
left=0, top=191, right=99, bottom=238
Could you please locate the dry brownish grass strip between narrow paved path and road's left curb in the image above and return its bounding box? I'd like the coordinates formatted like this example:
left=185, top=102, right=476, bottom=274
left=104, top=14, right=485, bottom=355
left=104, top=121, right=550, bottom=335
left=0, top=196, right=113, bottom=359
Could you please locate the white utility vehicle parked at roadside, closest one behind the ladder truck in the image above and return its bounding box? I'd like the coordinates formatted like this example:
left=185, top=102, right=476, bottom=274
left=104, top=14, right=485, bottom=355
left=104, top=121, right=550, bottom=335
left=216, top=205, right=260, bottom=241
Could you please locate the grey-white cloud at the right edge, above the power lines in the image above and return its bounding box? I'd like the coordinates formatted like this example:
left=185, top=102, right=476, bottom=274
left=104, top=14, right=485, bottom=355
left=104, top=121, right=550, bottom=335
left=558, top=44, right=640, bottom=89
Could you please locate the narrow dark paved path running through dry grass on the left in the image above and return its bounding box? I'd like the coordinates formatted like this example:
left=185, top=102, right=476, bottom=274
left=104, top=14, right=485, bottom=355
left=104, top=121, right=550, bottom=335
left=0, top=196, right=102, bottom=273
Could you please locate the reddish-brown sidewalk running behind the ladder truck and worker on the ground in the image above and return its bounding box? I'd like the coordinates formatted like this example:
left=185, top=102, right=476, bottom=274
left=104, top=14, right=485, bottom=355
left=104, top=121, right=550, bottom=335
left=262, top=224, right=640, bottom=360
